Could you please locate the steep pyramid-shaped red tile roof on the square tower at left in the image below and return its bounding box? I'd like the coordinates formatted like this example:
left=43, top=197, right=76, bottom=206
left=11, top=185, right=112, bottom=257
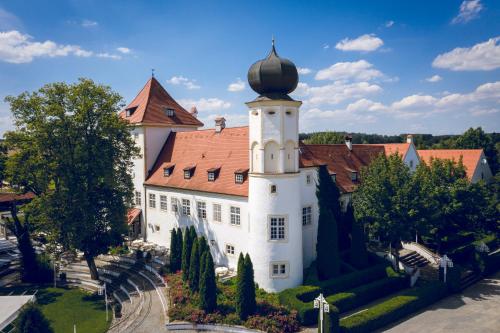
left=120, top=77, right=203, bottom=127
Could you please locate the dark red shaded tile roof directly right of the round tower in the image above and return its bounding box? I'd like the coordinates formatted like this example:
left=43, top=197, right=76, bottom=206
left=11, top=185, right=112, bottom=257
left=300, top=144, right=384, bottom=192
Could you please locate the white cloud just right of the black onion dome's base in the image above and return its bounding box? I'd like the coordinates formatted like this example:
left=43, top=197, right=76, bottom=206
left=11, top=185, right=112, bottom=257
left=294, top=81, right=382, bottom=105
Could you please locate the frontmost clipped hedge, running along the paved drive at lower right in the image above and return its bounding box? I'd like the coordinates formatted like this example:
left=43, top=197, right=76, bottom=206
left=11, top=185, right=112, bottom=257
left=340, top=282, right=447, bottom=333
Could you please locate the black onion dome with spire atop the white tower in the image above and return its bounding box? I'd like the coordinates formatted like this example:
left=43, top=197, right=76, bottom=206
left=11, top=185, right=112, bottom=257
left=248, top=41, right=299, bottom=99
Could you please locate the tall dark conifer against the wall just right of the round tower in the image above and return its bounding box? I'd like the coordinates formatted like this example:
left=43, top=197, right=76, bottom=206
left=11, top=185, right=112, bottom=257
left=316, top=166, right=340, bottom=280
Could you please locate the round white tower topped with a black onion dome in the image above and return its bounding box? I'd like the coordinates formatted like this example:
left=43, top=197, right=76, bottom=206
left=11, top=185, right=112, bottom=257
left=246, top=40, right=303, bottom=291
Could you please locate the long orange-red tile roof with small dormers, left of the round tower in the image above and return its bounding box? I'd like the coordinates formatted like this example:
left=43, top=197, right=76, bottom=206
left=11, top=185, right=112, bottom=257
left=145, top=127, right=249, bottom=196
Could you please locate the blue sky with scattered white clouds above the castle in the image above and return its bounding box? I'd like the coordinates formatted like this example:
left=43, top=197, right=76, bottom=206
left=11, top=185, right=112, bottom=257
left=0, top=0, right=500, bottom=134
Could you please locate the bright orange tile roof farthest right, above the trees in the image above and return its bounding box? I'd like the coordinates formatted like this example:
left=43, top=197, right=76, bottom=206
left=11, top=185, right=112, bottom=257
left=417, top=149, right=483, bottom=180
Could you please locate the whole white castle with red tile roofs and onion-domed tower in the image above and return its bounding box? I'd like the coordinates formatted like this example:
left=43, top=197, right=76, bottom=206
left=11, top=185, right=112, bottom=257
left=120, top=41, right=492, bottom=291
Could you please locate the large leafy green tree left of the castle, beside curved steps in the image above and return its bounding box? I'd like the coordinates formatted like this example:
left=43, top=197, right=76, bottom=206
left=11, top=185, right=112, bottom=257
left=6, top=79, right=138, bottom=279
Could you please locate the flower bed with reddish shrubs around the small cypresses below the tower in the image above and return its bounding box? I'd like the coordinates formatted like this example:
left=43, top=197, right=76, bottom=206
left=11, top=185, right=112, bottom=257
left=166, top=273, right=300, bottom=333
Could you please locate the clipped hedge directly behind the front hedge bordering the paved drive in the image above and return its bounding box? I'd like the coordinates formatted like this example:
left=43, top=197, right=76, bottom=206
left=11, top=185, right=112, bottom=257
left=326, top=277, right=409, bottom=313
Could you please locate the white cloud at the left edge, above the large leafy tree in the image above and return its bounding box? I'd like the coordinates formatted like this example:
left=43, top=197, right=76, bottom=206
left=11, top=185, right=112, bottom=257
left=0, top=30, right=98, bottom=64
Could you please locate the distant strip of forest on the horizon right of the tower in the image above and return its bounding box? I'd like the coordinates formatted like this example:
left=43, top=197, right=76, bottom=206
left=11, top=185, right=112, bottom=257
left=299, top=127, right=500, bottom=174
